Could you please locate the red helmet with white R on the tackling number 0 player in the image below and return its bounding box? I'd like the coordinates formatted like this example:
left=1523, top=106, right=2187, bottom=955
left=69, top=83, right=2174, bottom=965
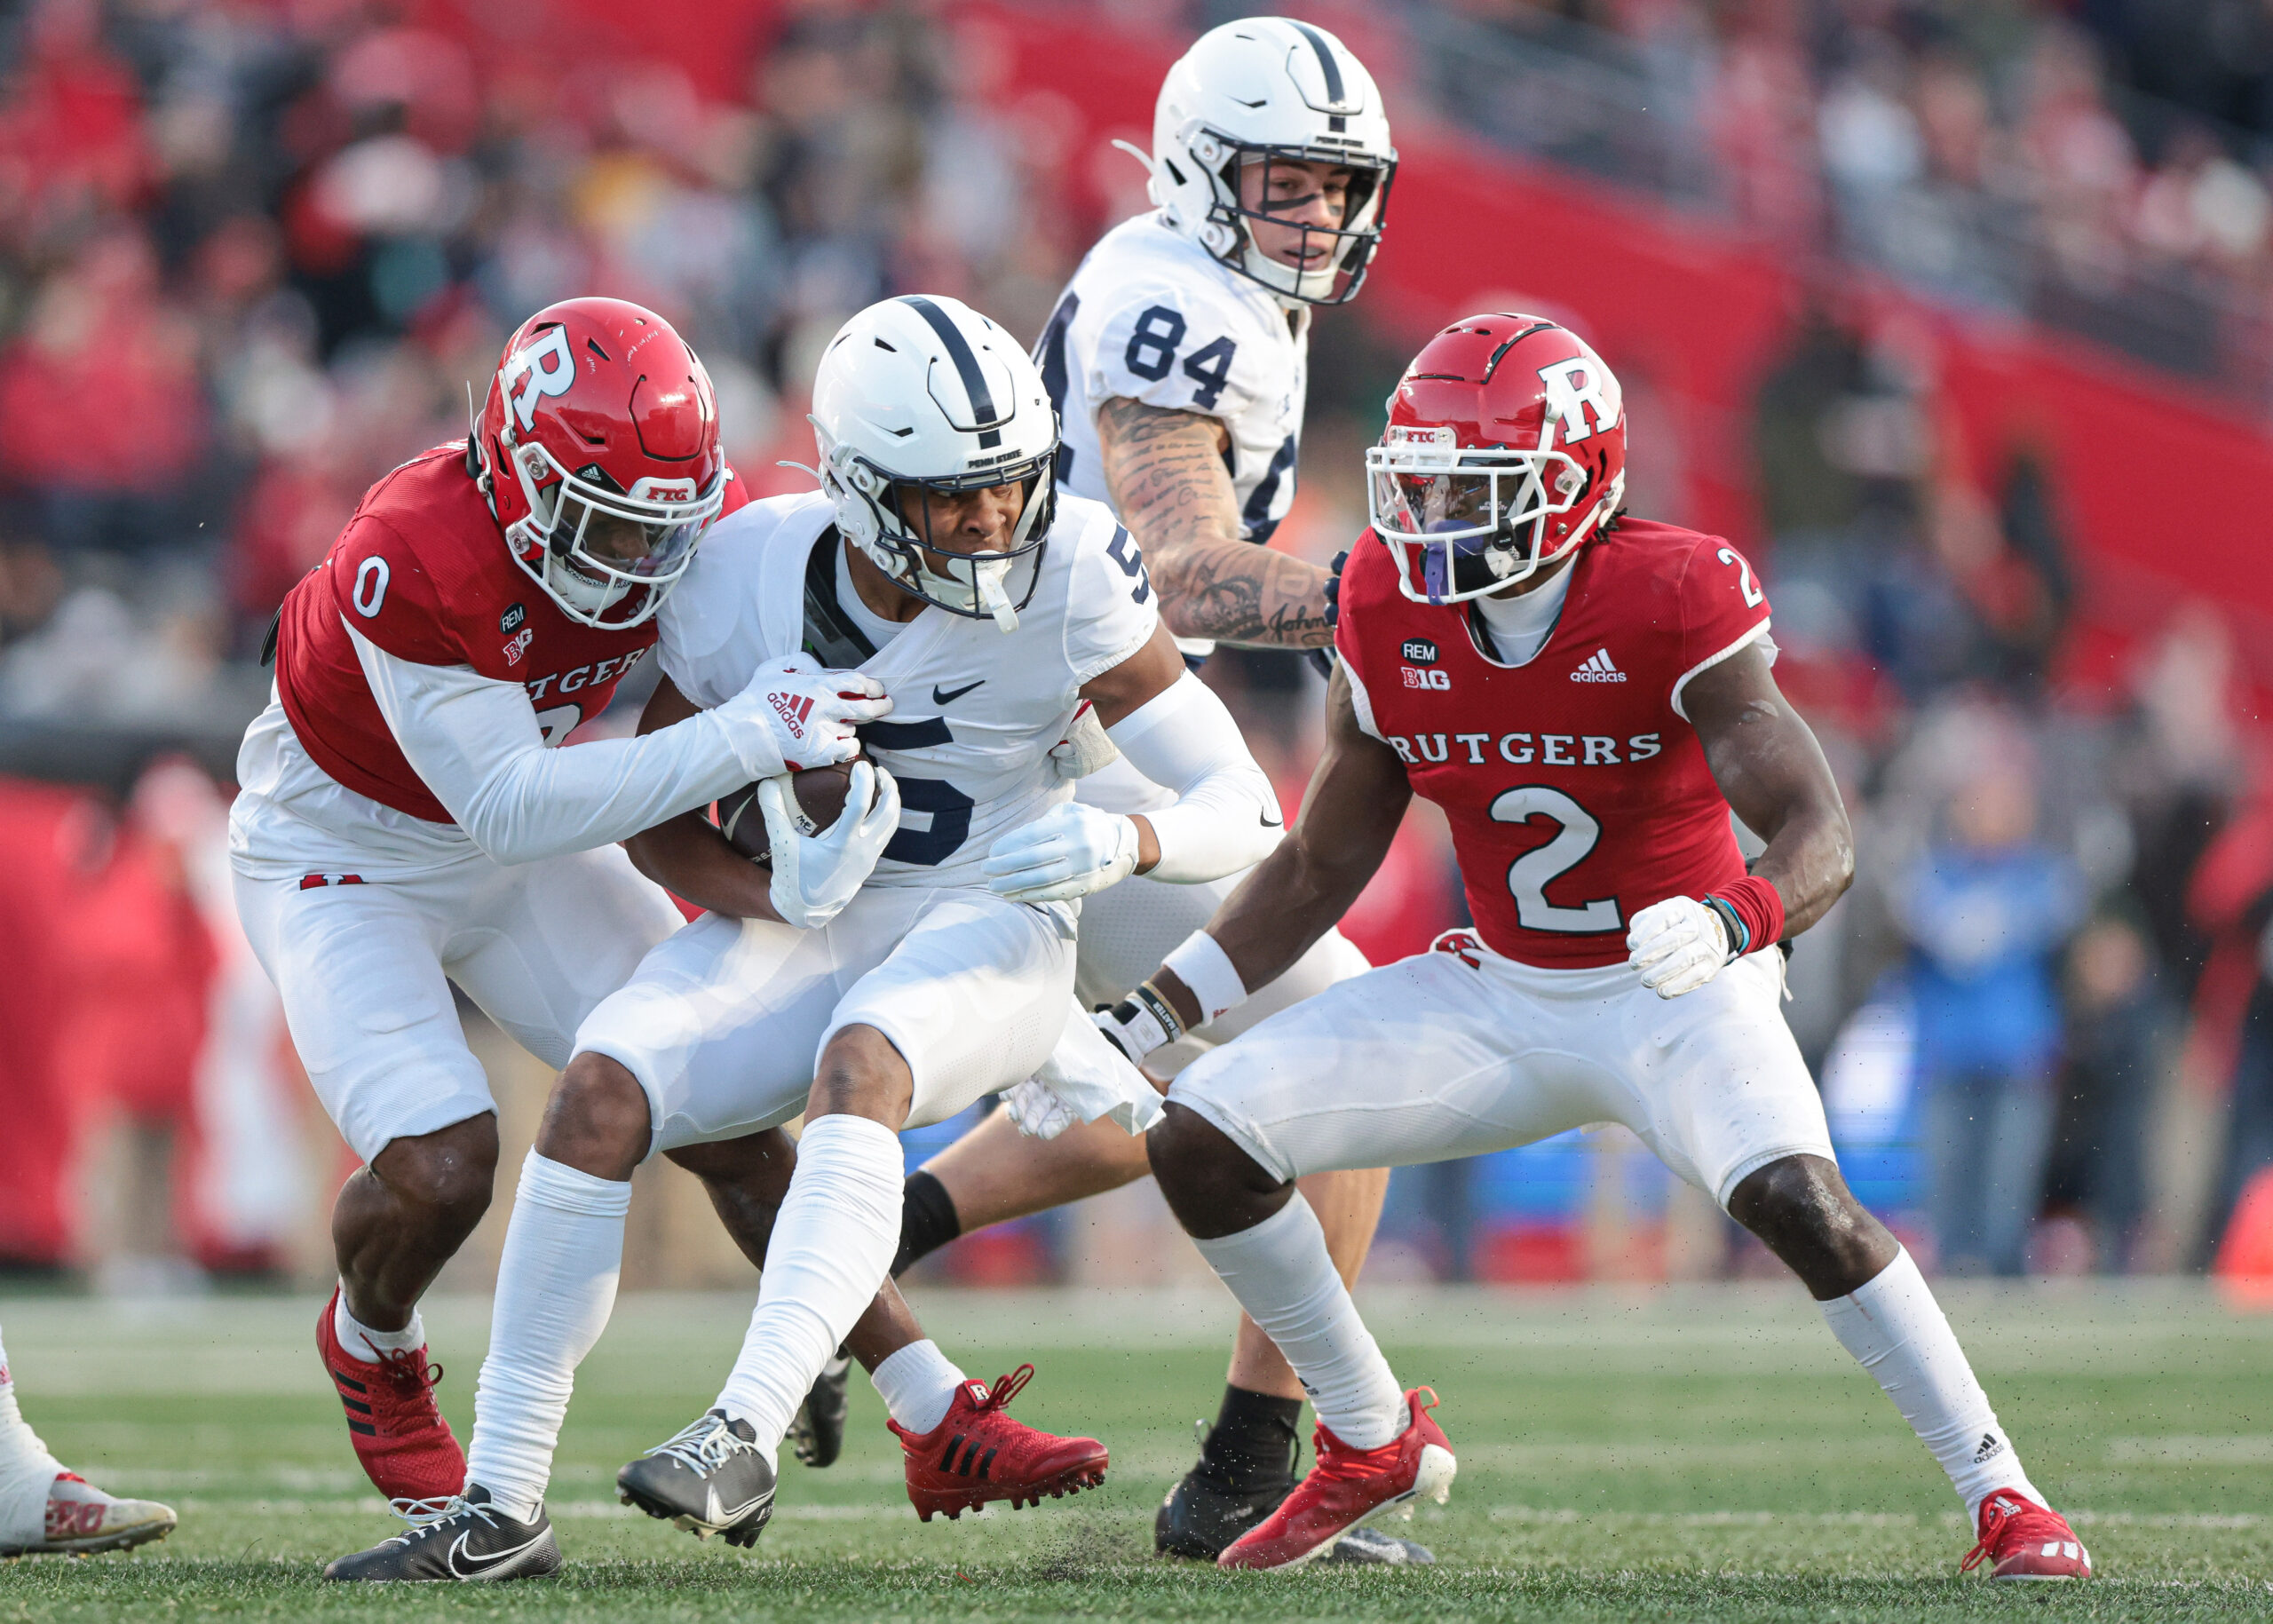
left=472, top=298, right=727, bottom=628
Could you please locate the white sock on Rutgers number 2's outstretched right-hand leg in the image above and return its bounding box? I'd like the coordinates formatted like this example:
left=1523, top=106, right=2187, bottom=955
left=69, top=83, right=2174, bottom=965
left=1816, top=1248, right=2046, bottom=1517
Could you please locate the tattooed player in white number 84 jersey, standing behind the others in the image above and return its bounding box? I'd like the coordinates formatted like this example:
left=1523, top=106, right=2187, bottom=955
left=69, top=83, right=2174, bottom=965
left=867, top=16, right=1425, bottom=1560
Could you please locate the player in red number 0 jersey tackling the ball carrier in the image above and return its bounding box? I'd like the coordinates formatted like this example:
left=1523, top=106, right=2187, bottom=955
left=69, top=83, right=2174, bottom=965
left=230, top=298, right=889, bottom=1501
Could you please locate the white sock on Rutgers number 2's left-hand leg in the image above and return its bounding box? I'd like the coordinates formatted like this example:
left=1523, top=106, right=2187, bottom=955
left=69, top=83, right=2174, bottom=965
left=1193, top=1190, right=1409, bottom=1449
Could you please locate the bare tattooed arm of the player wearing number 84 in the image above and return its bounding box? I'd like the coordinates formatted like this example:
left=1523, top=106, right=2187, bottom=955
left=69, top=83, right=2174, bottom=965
left=1097, top=398, right=1334, bottom=648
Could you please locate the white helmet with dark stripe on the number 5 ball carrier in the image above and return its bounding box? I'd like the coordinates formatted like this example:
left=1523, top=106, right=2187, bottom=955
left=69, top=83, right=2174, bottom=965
left=812, top=293, right=1057, bottom=632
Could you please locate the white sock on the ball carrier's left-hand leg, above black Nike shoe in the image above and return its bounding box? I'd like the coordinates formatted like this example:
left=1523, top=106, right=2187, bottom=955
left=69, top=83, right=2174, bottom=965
left=466, top=1151, right=632, bottom=1522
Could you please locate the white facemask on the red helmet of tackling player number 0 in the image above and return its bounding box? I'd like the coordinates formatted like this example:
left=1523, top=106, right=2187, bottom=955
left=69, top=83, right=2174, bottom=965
left=500, top=441, right=725, bottom=630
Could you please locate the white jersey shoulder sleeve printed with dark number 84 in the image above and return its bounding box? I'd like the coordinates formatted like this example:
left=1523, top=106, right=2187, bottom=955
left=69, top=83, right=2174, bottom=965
left=1077, top=282, right=1268, bottom=418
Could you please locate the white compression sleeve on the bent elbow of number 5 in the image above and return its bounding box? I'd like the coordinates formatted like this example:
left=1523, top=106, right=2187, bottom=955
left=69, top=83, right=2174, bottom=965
left=1105, top=671, right=1287, bottom=884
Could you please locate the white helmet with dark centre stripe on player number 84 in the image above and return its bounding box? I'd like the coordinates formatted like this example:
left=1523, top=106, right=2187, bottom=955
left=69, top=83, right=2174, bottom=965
left=1145, top=16, right=1398, bottom=305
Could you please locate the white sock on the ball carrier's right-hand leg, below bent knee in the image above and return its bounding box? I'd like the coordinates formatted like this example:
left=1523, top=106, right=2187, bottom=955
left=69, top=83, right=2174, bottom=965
left=718, top=1114, right=907, bottom=1461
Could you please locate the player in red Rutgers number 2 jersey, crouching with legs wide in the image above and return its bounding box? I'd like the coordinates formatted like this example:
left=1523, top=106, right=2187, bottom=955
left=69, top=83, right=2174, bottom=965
left=1100, top=316, right=2091, bottom=1579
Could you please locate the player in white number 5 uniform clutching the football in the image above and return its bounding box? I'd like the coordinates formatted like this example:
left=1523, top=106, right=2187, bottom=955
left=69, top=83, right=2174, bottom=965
left=332, top=296, right=1282, bottom=1579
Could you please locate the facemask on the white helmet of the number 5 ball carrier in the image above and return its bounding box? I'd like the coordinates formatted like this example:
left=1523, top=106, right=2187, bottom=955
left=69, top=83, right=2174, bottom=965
left=813, top=421, right=1057, bottom=632
